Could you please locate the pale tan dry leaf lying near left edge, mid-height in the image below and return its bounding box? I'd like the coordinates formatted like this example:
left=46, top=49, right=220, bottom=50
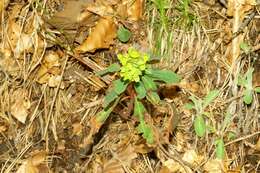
left=11, top=89, right=31, bottom=123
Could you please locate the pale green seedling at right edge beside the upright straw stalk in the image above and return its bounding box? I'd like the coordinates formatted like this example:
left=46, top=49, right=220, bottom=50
left=238, top=67, right=260, bottom=105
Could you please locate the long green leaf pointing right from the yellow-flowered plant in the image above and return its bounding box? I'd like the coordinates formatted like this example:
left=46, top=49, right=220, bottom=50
left=147, top=69, right=181, bottom=84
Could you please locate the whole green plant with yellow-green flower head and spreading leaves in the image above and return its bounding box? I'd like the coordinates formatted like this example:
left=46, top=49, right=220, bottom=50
left=96, top=48, right=181, bottom=144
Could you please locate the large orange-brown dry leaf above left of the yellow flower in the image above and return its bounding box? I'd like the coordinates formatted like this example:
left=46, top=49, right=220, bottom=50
left=76, top=17, right=116, bottom=53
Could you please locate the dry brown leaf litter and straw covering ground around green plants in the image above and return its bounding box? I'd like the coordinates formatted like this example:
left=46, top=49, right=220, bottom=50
left=0, top=0, right=260, bottom=173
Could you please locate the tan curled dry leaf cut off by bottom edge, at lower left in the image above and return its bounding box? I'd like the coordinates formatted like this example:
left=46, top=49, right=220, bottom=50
left=16, top=151, right=49, bottom=173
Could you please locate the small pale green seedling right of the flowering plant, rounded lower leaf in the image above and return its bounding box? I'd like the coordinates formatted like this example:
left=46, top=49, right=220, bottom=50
left=185, top=90, right=219, bottom=137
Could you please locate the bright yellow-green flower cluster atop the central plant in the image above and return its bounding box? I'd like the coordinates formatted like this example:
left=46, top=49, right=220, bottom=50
left=118, top=48, right=149, bottom=82
